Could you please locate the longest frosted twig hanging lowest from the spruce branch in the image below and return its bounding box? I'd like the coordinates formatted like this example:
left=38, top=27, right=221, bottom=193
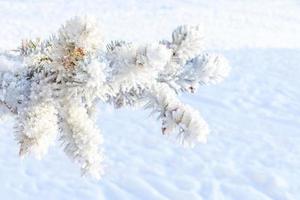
left=60, top=103, right=103, bottom=179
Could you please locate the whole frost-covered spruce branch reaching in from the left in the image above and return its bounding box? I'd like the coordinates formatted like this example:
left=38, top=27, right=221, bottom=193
left=0, top=17, right=230, bottom=178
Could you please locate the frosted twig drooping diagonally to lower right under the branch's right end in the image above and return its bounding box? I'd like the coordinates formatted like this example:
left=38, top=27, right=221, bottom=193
left=148, top=84, right=209, bottom=147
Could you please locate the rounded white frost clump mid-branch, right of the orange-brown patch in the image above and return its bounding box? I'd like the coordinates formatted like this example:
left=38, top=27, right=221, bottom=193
left=108, top=44, right=171, bottom=87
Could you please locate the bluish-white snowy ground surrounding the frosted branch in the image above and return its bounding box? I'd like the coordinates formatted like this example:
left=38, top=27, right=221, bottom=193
left=0, top=0, right=300, bottom=200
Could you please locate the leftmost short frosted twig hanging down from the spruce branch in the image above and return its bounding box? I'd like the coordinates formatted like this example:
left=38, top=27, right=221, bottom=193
left=16, top=102, right=58, bottom=159
